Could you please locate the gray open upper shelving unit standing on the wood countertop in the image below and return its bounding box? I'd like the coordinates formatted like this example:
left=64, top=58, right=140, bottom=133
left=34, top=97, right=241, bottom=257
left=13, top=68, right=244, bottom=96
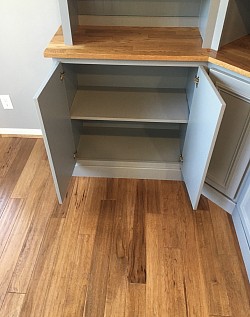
left=59, top=0, right=229, bottom=50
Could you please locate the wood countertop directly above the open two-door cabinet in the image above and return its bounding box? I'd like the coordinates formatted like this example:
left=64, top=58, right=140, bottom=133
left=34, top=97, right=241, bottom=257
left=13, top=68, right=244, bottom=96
left=44, top=26, right=208, bottom=61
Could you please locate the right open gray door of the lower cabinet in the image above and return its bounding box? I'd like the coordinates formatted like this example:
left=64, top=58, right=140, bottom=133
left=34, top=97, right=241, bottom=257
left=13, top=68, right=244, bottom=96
left=182, top=67, right=225, bottom=210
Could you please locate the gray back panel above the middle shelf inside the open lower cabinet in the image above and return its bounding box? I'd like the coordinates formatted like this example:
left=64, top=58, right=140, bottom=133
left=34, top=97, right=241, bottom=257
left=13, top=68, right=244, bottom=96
left=72, top=65, right=188, bottom=89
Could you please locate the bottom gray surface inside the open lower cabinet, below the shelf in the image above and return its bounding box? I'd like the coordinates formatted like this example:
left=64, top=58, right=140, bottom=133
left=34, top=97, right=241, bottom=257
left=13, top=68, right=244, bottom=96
left=77, top=135, right=180, bottom=166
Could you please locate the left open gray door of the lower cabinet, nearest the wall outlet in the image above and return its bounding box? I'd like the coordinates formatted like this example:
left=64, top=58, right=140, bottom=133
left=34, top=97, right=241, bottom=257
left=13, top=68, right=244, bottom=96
left=34, top=63, right=75, bottom=203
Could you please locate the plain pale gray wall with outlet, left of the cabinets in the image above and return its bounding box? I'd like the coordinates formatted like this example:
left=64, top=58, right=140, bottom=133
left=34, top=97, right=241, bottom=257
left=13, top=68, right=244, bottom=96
left=0, top=0, right=61, bottom=131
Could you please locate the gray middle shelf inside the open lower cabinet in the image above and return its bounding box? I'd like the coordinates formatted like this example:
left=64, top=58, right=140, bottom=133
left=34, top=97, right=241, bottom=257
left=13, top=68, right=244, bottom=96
left=70, top=88, right=188, bottom=123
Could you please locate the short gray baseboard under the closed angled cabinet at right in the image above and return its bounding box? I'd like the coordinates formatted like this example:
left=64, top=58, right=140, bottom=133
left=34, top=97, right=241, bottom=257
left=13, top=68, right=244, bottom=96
left=202, top=183, right=235, bottom=214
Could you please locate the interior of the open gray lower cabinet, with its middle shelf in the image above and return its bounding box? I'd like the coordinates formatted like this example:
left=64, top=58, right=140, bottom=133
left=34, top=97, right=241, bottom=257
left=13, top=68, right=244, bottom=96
left=63, top=64, right=197, bottom=168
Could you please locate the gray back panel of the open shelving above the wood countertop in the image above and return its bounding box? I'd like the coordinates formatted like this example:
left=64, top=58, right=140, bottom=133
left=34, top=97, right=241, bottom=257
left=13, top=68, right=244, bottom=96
left=78, top=0, right=201, bottom=17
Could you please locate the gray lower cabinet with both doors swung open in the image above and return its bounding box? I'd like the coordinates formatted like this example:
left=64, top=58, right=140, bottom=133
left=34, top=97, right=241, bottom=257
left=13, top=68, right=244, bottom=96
left=35, top=62, right=225, bottom=209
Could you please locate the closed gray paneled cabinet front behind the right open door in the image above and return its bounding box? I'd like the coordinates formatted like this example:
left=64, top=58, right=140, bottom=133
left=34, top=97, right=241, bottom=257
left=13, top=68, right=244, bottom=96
left=206, top=69, right=250, bottom=201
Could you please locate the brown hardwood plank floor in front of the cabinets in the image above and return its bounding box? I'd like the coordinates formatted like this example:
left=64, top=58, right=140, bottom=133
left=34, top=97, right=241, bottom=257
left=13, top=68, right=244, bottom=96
left=0, top=137, right=250, bottom=317
